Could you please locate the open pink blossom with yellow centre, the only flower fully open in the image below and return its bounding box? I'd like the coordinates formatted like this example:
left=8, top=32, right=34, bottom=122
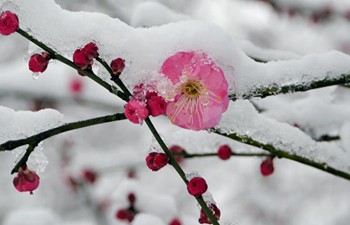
left=161, top=52, right=229, bottom=130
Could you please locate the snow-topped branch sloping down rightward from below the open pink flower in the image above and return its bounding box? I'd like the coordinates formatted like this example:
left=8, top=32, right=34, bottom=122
left=213, top=101, right=350, bottom=179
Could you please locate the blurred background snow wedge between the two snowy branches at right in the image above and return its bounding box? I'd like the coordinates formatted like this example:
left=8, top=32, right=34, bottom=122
left=254, top=87, right=350, bottom=140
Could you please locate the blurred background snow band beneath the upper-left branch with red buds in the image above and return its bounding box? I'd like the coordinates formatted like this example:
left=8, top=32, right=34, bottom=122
left=0, top=57, right=121, bottom=110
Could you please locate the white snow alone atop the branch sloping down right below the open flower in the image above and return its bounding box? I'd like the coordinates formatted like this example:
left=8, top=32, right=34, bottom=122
left=217, top=100, right=350, bottom=173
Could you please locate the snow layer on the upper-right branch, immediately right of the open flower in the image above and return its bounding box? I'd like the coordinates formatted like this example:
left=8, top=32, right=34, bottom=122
left=233, top=51, right=350, bottom=96
